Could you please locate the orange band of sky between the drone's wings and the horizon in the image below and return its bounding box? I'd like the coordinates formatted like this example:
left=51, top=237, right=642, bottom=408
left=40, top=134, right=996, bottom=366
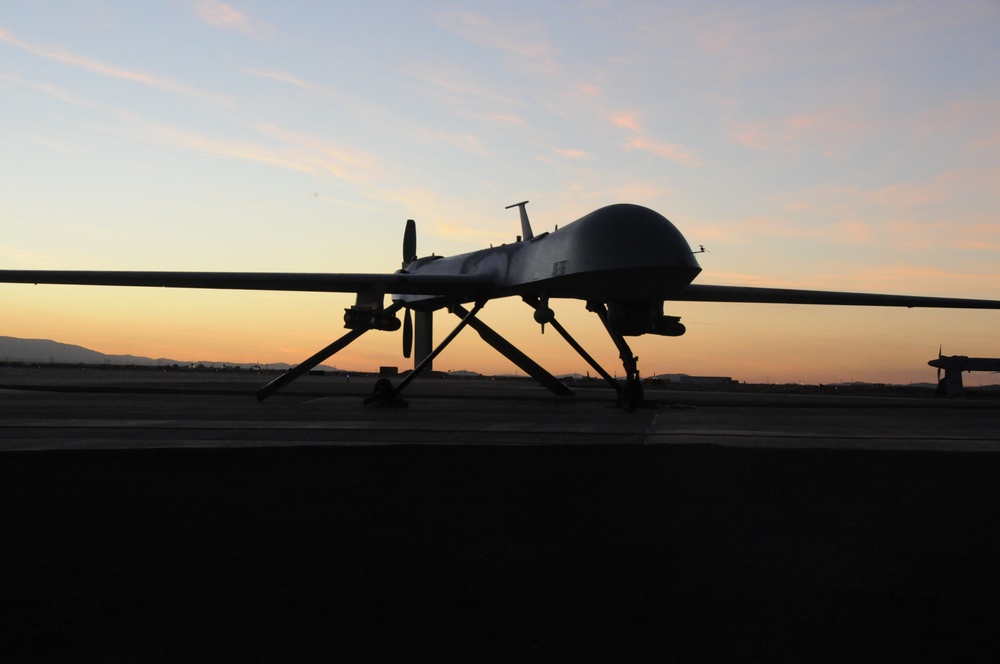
left=0, top=285, right=996, bottom=383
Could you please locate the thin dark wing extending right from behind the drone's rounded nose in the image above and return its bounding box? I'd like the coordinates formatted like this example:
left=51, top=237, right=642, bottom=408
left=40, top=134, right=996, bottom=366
left=671, top=284, right=1000, bottom=309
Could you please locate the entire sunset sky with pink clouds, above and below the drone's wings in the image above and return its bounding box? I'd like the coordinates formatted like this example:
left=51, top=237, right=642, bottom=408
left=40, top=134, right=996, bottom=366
left=0, top=0, right=1000, bottom=385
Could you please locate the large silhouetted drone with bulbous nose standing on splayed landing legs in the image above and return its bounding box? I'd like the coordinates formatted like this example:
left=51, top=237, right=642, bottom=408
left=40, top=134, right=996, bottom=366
left=0, top=201, right=1000, bottom=411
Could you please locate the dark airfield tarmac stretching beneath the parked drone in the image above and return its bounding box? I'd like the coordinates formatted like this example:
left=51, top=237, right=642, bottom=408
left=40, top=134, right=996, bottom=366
left=0, top=368, right=1000, bottom=661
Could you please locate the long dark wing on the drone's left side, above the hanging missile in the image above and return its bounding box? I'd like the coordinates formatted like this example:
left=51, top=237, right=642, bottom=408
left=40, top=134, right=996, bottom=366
left=0, top=270, right=492, bottom=300
